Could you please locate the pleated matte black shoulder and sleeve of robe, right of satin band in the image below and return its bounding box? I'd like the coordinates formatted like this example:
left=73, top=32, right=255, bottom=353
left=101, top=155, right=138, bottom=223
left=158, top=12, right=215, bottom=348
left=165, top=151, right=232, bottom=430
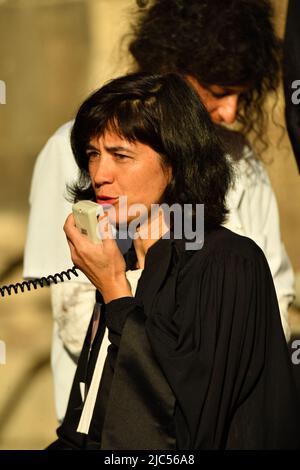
left=146, top=229, right=300, bottom=449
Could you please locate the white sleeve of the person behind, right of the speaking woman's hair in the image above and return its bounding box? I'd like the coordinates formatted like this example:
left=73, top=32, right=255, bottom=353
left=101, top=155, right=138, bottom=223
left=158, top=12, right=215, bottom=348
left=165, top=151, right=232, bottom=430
left=226, top=146, right=294, bottom=341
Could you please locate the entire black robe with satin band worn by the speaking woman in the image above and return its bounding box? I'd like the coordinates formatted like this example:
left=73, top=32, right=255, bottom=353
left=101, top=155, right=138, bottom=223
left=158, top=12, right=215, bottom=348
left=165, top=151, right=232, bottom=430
left=50, top=228, right=300, bottom=450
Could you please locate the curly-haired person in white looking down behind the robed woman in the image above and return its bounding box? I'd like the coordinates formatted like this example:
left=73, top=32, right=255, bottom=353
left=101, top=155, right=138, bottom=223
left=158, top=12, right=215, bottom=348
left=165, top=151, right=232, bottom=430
left=24, top=0, right=294, bottom=420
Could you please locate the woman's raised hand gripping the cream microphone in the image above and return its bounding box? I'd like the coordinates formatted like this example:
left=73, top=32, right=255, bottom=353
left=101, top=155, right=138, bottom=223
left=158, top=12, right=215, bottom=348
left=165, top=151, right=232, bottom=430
left=64, top=214, right=132, bottom=303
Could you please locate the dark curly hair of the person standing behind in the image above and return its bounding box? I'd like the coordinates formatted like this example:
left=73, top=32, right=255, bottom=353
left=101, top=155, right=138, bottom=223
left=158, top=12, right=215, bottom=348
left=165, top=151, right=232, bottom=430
left=129, top=0, right=281, bottom=149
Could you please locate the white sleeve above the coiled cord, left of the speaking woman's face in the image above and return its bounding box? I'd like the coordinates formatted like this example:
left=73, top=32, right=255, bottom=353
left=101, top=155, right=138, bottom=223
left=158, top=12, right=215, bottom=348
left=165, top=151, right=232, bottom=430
left=23, top=123, right=88, bottom=282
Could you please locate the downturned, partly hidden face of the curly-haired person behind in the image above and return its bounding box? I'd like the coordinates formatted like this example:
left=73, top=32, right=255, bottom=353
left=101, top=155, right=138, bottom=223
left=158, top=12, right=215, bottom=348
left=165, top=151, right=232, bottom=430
left=187, top=76, right=248, bottom=124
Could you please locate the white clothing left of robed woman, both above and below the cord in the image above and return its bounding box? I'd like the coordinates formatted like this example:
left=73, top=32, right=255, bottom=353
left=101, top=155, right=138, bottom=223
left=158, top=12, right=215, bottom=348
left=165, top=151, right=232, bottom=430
left=23, top=123, right=95, bottom=420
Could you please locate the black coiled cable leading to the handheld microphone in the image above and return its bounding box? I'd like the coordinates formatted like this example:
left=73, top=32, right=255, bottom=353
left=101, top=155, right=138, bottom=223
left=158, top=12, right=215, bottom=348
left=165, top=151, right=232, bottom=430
left=0, top=266, right=78, bottom=297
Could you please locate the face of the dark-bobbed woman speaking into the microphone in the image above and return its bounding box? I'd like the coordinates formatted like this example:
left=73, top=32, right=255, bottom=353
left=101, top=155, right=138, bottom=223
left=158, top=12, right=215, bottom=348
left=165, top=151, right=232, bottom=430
left=86, top=131, right=172, bottom=225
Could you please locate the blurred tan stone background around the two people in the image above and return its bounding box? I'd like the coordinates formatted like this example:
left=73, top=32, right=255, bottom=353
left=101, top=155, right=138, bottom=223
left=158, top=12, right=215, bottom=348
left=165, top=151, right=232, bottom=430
left=0, top=0, right=300, bottom=449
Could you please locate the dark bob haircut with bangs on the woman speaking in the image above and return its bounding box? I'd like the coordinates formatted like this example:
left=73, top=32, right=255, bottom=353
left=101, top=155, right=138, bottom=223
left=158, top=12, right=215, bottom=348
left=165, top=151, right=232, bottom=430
left=71, top=73, right=231, bottom=230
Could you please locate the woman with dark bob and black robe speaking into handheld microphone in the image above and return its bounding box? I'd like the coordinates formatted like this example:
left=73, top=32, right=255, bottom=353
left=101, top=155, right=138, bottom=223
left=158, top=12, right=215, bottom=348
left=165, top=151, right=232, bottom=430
left=49, top=74, right=299, bottom=450
